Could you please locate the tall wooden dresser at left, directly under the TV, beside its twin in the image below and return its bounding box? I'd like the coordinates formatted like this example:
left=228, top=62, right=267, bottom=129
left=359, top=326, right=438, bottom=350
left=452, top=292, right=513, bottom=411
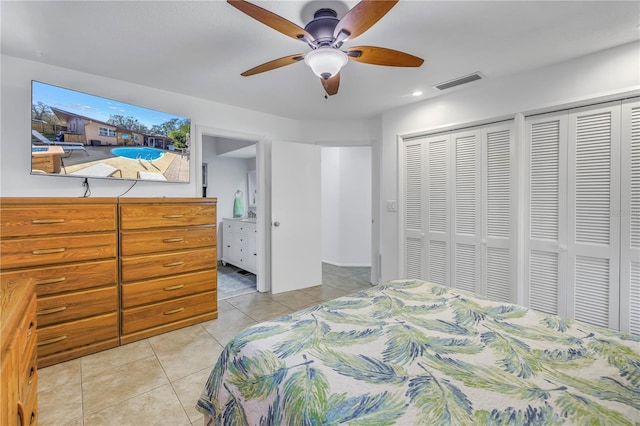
left=0, top=198, right=118, bottom=367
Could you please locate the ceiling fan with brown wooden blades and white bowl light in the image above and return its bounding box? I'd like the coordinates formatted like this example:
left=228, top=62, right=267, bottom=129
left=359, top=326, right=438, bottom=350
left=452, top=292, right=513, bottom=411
left=227, top=0, right=424, bottom=97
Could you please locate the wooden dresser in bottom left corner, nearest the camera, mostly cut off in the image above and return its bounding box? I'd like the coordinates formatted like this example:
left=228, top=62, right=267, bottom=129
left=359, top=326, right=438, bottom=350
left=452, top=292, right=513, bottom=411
left=0, top=279, right=38, bottom=425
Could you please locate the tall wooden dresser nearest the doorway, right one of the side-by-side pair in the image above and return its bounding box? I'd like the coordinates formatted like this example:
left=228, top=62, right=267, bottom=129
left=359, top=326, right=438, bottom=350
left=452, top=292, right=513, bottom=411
left=119, top=198, right=218, bottom=344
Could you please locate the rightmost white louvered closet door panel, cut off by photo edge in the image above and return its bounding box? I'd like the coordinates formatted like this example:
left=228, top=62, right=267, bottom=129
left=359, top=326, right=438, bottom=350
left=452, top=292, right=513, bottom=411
left=620, top=98, right=640, bottom=336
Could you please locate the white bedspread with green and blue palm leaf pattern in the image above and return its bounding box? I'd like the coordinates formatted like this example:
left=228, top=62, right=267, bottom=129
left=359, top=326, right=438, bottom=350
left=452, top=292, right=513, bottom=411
left=197, top=280, right=640, bottom=425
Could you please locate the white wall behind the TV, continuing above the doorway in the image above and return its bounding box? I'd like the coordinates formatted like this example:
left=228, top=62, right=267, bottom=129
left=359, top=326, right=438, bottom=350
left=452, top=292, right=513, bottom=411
left=0, top=55, right=370, bottom=197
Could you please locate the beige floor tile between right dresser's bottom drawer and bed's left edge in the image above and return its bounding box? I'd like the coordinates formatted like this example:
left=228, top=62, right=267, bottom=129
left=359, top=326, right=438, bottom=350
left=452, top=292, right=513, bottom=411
left=149, top=324, right=223, bottom=381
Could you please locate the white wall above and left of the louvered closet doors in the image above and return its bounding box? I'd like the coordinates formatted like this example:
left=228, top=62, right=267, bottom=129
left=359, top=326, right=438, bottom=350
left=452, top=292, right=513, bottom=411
left=373, top=42, right=640, bottom=281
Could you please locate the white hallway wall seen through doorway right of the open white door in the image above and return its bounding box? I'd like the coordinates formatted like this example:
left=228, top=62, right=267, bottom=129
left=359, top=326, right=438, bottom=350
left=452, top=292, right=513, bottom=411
left=322, top=147, right=371, bottom=266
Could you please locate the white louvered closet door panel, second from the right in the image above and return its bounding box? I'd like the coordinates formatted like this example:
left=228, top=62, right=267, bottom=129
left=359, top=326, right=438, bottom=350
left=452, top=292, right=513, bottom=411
left=567, top=102, right=620, bottom=329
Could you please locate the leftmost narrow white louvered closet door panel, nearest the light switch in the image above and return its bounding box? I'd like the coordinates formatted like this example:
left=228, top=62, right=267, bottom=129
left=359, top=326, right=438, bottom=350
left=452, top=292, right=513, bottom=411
left=403, top=140, right=427, bottom=279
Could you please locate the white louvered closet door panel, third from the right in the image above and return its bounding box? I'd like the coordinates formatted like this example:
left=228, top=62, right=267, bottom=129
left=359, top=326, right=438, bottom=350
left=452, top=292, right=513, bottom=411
left=523, top=112, right=568, bottom=315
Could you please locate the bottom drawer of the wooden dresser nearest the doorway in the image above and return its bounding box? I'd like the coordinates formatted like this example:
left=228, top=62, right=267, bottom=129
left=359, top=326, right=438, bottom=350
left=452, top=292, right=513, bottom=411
left=122, top=291, right=217, bottom=334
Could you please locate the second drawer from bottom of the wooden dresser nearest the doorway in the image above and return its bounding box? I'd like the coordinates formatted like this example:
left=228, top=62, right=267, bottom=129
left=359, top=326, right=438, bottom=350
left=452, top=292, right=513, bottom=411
left=122, top=269, right=217, bottom=308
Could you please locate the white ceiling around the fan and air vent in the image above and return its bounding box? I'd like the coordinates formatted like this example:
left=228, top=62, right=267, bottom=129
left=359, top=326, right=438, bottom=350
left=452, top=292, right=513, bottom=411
left=0, top=0, right=640, bottom=120
